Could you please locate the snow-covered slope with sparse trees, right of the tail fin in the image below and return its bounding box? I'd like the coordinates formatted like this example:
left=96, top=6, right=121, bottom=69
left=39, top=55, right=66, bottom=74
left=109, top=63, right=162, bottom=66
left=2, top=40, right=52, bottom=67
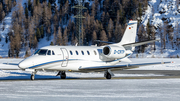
left=133, top=0, right=180, bottom=57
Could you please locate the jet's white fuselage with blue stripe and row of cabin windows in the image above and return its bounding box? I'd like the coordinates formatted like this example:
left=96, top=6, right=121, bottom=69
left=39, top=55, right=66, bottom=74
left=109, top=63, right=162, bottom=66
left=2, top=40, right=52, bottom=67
left=19, top=46, right=125, bottom=72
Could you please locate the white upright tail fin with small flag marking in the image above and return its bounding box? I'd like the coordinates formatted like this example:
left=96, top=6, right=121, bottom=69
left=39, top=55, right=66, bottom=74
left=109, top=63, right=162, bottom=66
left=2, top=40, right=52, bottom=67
left=119, top=20, right=137, bottom=45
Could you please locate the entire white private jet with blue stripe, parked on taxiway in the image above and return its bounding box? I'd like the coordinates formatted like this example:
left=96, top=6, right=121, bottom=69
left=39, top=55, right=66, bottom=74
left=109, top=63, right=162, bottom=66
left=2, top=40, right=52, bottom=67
left=2, top=20, right=170, bottom=80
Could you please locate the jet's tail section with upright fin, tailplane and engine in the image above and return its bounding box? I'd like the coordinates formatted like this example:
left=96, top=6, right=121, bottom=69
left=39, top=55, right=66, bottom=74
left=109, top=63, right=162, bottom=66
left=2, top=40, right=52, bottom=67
left=99, top=20, right=157, bottom=64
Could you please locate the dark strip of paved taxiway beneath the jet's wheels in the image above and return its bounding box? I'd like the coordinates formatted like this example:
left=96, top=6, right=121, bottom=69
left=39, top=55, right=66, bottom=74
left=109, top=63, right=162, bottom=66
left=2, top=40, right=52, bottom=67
left=0, top=70, right=180, bottom=82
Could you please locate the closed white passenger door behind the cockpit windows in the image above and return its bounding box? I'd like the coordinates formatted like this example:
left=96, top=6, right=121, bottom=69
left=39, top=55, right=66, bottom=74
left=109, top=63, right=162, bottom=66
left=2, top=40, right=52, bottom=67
left=61, top=48, right=69, bottom=67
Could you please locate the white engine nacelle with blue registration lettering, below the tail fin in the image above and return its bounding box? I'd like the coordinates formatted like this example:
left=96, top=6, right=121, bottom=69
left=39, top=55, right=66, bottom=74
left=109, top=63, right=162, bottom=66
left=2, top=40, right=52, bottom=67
left=103, top=46, right=126, bottom=59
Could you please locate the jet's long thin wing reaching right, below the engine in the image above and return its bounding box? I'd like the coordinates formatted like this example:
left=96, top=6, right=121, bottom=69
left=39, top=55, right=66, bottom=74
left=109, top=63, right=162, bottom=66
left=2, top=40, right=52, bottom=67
left=79, top=62, right=171, bottom=71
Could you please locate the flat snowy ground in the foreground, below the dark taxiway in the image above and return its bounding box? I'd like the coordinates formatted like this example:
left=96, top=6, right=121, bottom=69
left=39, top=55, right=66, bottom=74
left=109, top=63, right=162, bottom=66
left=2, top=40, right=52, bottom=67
left=0, top=79, right=180, bottom=101
